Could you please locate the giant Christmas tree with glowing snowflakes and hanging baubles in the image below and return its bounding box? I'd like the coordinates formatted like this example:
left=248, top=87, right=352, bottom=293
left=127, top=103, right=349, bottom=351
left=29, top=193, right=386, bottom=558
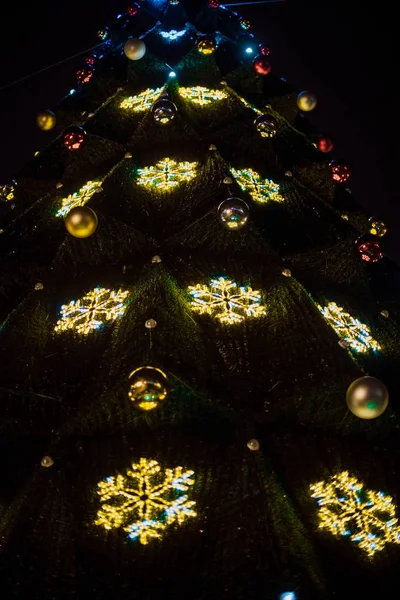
left=0, top=0, right=400, bottom=600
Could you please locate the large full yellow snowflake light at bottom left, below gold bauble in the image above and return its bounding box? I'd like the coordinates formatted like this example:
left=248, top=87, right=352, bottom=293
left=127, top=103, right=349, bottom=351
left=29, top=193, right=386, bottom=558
left=95, top=458, right=196, bottom=544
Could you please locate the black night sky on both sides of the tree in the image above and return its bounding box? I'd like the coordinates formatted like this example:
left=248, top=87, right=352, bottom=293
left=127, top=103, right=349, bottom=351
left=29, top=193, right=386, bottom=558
left=0, top=0, right=394, bottom=263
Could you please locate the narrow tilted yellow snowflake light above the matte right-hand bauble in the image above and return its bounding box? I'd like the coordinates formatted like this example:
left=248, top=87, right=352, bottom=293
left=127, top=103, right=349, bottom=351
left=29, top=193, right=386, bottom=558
left=317, top=302, right=380, bottom=352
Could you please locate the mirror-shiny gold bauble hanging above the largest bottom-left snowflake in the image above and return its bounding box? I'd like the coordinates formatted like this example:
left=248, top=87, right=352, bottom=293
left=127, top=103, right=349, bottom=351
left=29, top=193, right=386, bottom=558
left=128, top=367, right=169, bottom=411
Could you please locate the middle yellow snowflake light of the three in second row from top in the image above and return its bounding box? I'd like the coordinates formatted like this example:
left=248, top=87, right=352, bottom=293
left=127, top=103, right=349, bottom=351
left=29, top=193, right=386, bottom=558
left=136, top=158, right=198, bottom=192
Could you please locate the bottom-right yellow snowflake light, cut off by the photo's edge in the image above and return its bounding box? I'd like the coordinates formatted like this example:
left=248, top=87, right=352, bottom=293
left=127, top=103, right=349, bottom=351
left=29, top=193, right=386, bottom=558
left=310, top=471, right=400, bottom=556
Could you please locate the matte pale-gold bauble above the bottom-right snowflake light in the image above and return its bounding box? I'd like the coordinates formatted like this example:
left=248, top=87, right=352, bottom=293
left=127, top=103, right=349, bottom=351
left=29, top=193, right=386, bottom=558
left=346, top=376, right=389, bottom=419
